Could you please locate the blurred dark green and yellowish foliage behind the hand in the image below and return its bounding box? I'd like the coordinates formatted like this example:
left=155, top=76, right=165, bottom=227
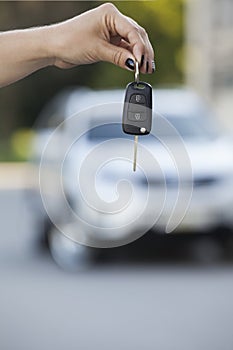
left=0, top=0, right=185, bottom=161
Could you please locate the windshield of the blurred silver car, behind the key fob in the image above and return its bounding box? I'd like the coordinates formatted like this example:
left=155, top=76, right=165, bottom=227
left=88, top=116, right=217, bottom=142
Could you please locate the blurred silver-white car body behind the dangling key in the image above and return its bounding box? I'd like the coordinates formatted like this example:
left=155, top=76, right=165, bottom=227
left=33, top=88, right=233, bottom=262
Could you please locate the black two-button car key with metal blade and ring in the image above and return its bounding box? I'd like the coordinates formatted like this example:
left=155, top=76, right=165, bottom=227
left=122, top=62, right=152, bottom=171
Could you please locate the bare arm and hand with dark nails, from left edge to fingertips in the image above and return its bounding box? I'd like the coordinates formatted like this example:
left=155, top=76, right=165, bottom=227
left=0, top=3, right=154, bottom=87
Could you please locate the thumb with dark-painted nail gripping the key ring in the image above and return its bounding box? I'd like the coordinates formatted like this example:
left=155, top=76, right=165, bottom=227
left=101, top=43, right=135, bottom=71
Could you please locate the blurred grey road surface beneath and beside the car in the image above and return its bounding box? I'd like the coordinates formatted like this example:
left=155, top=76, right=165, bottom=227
left=0, top=165, right=233, bottom=350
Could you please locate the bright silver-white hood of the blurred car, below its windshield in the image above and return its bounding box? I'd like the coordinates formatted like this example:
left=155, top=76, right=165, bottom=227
left=64, top=138, right=233, bottom=187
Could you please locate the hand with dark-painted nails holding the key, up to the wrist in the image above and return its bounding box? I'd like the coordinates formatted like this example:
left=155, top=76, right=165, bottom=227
left=47, top=3, right=155, bottom=73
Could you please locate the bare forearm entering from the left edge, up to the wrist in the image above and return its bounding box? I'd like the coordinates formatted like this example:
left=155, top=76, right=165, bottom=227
left=0, top=27, right=54, bottom=87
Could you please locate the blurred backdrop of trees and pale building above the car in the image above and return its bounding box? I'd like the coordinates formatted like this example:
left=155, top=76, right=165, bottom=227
left=0, top=0, right=233, bottom=161
